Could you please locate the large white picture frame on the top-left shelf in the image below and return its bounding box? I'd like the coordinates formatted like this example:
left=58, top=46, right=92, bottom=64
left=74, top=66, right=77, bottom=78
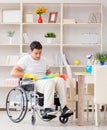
left=2, top=9, right=21, bottom=23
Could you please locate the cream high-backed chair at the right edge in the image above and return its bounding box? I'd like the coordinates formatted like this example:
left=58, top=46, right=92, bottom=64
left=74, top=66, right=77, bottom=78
left=94, top=65, right=107, bottom=126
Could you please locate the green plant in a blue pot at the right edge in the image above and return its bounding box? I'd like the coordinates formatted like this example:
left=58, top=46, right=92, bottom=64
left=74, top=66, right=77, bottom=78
left=95, top=52, right=107, bottom=65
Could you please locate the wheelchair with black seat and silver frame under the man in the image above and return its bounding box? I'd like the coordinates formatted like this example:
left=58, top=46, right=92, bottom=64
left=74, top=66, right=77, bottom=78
left=6, top=79, right=69, bottom=125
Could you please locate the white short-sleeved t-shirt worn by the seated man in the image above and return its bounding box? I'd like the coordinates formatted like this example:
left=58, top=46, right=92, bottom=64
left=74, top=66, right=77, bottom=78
left=17, top=55, right=49, bottom=78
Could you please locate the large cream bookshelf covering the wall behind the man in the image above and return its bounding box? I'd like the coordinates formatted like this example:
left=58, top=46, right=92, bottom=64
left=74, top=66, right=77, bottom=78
left=0, top=1, right=103, bottom=106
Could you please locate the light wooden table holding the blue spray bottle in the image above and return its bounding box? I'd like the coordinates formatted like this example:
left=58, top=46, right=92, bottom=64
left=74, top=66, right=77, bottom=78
left=75, top=72, right=93, bottom=126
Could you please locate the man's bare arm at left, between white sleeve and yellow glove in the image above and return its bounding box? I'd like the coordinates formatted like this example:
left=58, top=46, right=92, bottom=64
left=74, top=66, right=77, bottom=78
left=10, top=65, right=24, bottom=78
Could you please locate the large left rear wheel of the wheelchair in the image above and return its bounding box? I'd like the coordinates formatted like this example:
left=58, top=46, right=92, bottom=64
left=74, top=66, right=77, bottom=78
left=6, top=87, right=28, bottom=123
